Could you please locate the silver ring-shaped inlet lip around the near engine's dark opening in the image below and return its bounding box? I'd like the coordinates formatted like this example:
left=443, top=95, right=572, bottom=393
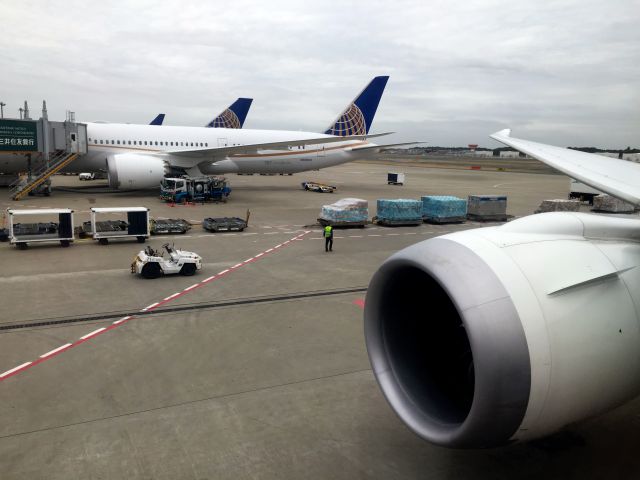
left=364, top=238, right=531, bottom=448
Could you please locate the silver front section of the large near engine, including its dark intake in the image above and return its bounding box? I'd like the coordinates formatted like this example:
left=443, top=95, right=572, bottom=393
left=364, top=238, right=531, bottom=448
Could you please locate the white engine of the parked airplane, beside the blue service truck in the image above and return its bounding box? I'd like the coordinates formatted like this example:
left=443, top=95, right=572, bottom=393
left=107, top=153, right=168, bottom=190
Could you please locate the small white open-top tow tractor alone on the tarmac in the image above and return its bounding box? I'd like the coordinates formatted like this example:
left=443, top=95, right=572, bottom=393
left=131, top=243, right=202, bottom=278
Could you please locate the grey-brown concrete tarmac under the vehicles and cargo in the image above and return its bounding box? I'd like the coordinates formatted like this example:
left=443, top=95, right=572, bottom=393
left=0, top=163, right=640, bottom=480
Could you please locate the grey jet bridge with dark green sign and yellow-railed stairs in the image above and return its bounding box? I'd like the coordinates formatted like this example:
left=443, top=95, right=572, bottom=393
left=0, top=102, right=87, bottom=200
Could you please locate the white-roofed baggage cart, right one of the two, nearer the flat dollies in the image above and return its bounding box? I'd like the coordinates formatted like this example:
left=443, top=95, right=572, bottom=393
left=91, top=207, right=150, bottom=245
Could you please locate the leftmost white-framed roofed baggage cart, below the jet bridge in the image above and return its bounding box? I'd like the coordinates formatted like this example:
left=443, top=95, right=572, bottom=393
left=7, top=208, right=73, bottom=250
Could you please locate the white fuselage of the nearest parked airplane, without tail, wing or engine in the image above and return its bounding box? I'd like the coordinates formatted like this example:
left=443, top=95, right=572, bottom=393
left=0, top=123, right=373, bottom=175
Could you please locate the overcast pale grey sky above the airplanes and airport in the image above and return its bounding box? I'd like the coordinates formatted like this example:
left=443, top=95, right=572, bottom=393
left=0, top=0, right=640, bottom=148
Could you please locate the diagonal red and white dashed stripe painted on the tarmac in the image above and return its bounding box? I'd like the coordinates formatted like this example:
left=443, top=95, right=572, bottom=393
left=0, top=230, right=311, bottom=382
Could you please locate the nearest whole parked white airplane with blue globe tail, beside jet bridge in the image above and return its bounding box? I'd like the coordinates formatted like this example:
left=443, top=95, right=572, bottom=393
left=60, top=77, right=404, bottom=189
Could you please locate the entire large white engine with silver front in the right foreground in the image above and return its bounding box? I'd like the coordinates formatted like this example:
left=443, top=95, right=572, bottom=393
left=365, top=213, right=640, bottom=448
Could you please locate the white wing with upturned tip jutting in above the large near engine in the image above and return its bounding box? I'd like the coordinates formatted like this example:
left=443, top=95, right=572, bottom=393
left=491, top=128, right=640, bottom=205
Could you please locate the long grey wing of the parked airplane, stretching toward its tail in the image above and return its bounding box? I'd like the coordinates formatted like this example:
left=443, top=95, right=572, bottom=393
left=158, top=132, right=393, bottom=168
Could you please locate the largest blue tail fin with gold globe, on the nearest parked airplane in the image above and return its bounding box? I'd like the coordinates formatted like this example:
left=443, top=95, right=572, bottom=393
left=324, top=76, right=389, bottom=137
